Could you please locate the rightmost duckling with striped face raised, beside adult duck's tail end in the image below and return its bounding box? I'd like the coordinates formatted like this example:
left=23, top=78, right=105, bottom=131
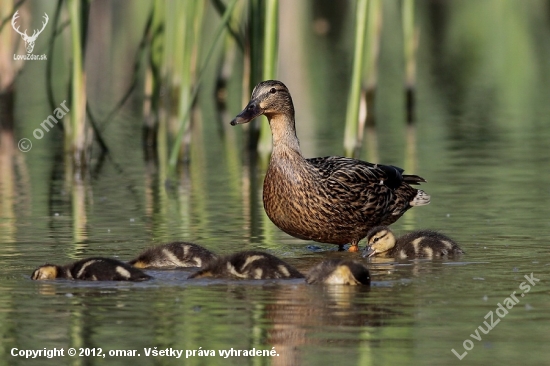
left=363, top=226, right=464, bottom=259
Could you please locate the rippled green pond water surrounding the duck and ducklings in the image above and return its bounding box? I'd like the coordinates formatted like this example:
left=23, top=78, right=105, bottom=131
left=4, top=109, right=550, bottom=365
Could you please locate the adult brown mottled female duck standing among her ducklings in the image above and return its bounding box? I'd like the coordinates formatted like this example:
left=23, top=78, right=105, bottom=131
left=231, top=80, right=430, bottom=252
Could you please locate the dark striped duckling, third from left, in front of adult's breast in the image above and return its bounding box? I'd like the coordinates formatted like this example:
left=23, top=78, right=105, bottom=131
left=189, top=250, right=304, bottom=280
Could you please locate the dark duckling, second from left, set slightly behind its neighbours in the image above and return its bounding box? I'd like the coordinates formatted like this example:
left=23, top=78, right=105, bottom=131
left=128, top=241, right=217, bottom=268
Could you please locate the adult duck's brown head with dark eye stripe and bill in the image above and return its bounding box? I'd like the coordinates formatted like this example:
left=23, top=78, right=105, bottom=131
left=231, top=80, right=294, bottom=126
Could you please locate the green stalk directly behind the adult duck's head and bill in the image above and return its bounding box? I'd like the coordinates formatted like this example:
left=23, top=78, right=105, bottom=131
left=258, top=0, right=279, bottom=160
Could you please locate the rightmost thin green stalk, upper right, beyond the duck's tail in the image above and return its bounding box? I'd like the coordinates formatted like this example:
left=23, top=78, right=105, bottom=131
left=402, top=0, right=418, bottom=123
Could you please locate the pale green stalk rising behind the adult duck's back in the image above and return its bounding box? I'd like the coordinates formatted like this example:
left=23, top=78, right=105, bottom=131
left=344, top=0, right=369, bottom=156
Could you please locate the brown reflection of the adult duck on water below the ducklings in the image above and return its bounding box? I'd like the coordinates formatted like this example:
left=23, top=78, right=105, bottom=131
left=265, top=286, right=399, bottom=365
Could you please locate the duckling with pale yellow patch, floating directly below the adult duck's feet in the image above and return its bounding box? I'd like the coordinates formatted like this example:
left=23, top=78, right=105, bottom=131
left=306, top=259, right=370, bottom=286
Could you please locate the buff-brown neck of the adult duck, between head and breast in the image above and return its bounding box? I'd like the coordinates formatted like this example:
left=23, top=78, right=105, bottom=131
left=266, top=113, right=302, bottom=156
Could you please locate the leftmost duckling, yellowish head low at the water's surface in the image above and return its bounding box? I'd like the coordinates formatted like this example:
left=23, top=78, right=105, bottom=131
left=31, top=257, right=152, bottom=281
